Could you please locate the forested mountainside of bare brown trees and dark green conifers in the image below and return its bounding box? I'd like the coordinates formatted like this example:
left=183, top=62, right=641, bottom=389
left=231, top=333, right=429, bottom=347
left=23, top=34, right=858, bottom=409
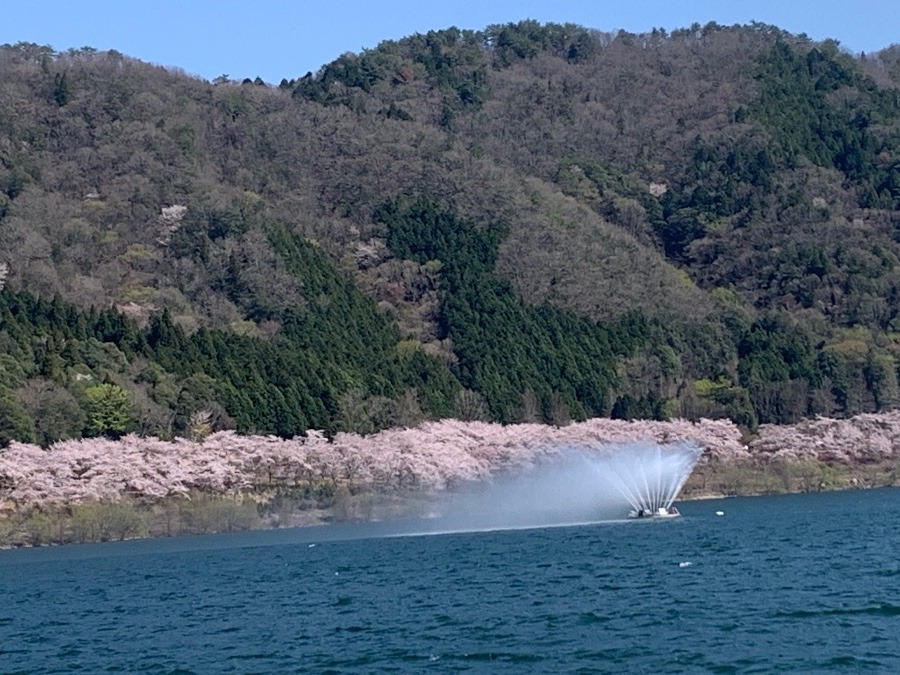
left=0, top=21, right=900, bottom=447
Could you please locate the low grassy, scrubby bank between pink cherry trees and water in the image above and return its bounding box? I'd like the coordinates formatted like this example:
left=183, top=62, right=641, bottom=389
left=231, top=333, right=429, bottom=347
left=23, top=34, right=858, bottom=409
left=0, top=460, right=900, bottom=550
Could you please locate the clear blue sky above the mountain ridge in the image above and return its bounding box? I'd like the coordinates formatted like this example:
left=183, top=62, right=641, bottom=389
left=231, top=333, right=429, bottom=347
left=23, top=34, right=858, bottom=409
left=0, top=0, right=900, bottom=83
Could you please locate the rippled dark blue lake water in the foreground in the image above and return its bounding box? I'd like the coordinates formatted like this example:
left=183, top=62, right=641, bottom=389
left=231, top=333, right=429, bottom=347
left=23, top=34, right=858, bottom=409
left=0, top=490, right=900, bottom=673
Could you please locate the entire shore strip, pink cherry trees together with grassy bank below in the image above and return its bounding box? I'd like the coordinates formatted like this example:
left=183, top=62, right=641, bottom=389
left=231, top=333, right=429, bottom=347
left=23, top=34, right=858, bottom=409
left=0, top=411, right=900, bottom=546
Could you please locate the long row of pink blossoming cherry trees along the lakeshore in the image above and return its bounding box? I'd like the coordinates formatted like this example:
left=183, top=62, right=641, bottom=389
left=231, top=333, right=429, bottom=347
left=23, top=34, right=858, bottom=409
left=0, top=412, right=900, bottom=508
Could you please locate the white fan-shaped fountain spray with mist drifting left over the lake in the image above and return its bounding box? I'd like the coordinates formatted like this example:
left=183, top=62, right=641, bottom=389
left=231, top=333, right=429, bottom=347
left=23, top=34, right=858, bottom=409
left=408, top=442, right=701, bottom=533
